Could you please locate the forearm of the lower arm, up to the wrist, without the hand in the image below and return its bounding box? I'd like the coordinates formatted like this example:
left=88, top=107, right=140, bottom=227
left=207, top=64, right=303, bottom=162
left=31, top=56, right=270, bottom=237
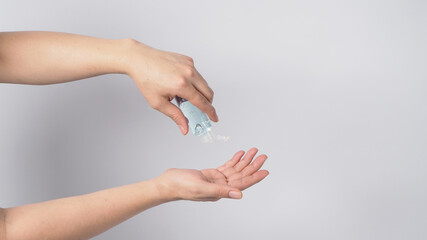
left=4, top=180, right=169, bottom=240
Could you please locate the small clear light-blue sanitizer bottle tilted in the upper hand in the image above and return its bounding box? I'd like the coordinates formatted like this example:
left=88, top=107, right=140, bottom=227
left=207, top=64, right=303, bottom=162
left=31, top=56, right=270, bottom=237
left=176, top=97, right=213, bottom=142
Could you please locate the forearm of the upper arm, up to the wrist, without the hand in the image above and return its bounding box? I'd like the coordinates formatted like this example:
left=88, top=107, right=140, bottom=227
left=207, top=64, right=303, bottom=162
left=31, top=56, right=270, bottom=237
left=0, top=32, right=132, bottom=84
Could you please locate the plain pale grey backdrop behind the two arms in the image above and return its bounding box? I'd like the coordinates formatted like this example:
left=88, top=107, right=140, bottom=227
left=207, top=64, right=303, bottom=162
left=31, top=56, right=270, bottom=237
left=0, top=0, right=427, bottom=240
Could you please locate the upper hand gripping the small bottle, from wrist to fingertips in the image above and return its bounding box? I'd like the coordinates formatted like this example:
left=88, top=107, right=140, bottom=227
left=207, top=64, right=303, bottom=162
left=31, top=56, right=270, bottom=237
left=123, top=41, right=218, bottom=135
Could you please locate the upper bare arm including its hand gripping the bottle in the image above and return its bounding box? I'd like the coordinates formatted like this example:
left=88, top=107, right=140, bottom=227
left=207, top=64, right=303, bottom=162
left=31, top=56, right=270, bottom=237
left=0, top=32, right=218, bottom=134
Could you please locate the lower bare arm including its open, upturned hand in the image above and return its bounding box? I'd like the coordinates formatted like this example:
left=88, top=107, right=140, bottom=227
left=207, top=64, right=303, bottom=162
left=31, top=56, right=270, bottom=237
left=0, top=149, right=268, bottom=240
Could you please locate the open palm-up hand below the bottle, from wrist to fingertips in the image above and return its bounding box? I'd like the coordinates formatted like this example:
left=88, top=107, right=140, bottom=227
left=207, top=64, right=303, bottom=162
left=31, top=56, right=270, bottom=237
left=155, top=148, right=269, bottom=201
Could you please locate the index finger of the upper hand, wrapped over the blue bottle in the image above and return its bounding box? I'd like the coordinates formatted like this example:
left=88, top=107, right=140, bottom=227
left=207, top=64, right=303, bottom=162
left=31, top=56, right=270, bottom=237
left=179, top=85, right=218, bottom=122
